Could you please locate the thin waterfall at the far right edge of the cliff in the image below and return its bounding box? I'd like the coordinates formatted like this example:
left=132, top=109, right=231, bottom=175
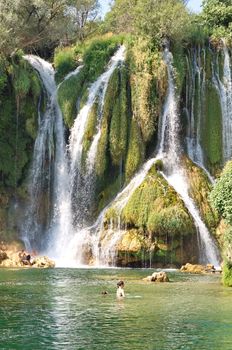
left=213, top=41, right=232, bottom=163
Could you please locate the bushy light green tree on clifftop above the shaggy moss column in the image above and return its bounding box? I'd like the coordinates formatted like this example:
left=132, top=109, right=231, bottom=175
left=103, top=0, right=190, bottom=45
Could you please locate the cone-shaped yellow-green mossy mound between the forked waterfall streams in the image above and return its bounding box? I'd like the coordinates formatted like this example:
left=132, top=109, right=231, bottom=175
left=122, top=167, right=195, bottom=236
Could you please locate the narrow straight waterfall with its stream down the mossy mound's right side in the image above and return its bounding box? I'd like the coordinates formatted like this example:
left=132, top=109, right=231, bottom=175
left=159, top=49, right=219, bottom=266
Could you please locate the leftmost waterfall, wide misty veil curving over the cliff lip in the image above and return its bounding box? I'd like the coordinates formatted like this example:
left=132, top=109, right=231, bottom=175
left=22, top=55, right=81, bottom=256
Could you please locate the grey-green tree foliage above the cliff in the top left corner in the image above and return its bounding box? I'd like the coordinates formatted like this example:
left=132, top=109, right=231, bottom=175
left=0, top=0, right=99, bottom=54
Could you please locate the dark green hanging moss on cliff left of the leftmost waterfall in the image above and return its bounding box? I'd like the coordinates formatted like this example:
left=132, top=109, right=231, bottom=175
left=0, top=54, right=41, bottom=187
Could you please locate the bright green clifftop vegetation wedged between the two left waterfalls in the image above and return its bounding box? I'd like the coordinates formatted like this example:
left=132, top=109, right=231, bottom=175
left=57, top=36, right=121, bottom=128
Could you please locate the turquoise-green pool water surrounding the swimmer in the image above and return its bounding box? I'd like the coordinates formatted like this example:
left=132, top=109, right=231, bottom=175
left=0, top=269, right=232, bottom=350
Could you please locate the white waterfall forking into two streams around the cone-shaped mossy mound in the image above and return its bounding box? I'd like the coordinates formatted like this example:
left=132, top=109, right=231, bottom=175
left=85, top=45, right=219, bottom=266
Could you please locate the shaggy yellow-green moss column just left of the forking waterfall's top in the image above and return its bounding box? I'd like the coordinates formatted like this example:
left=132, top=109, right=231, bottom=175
left=127, top=39, right=167, bottom=144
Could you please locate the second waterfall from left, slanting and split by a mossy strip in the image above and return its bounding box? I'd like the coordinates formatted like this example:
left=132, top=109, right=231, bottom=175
left=69, top=45, right=125, bottom=229
